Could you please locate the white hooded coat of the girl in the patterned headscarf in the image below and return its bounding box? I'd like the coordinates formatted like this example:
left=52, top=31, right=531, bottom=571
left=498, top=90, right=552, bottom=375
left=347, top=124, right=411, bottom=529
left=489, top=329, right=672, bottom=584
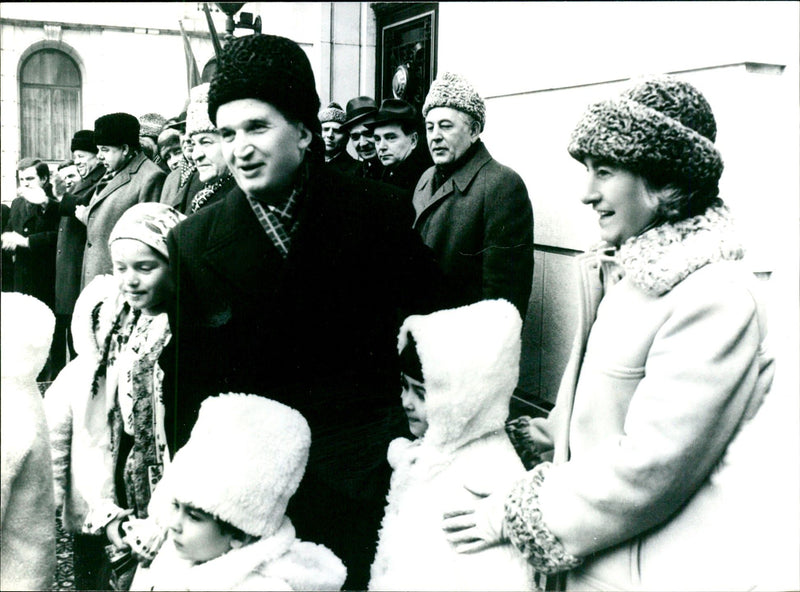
left=44, top=275, right=129, bottom=532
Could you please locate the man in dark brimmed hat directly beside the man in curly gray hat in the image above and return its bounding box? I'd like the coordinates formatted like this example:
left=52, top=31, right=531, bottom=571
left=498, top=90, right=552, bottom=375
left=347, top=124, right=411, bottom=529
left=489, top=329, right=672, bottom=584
left=367, top=99, right=433, bottom=193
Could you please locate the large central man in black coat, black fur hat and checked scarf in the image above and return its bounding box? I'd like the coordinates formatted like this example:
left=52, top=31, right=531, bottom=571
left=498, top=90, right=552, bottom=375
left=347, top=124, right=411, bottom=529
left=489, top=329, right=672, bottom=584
left=161, top=35, right=441, bottom=589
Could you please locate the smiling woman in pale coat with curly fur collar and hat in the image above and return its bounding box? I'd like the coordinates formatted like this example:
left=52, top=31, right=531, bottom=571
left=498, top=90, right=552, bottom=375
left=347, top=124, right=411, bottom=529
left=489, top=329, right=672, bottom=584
left=444, top=77, right=774, bottom=590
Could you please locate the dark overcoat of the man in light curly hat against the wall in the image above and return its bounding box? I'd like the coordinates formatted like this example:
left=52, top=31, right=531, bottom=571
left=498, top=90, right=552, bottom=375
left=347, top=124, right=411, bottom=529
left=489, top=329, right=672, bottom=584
left=413, top=140, right=533, bottom=318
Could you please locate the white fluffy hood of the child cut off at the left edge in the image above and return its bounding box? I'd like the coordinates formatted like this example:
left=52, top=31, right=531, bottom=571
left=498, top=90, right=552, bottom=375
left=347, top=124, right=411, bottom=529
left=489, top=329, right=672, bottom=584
left=0, top=292, right=56, bottom=379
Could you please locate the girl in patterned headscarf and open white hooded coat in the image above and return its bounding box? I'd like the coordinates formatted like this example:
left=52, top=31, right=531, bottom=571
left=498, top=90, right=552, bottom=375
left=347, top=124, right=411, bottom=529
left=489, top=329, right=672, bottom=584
left=45, top=203, right=185, bottom=588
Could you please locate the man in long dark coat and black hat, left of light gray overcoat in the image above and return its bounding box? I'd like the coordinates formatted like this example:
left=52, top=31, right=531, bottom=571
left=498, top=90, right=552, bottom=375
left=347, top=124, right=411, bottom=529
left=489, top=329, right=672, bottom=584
left=53, top=130, right=106, bottom=372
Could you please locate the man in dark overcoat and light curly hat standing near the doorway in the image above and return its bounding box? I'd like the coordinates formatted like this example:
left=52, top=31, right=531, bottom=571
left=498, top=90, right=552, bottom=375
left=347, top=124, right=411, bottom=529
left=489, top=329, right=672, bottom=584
left=413, top=73, right=533, bottom=319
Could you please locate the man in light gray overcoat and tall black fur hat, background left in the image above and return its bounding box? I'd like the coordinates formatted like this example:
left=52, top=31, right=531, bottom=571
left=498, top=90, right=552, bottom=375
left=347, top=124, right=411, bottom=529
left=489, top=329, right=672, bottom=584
left=75, top=113, right=166, bottom=289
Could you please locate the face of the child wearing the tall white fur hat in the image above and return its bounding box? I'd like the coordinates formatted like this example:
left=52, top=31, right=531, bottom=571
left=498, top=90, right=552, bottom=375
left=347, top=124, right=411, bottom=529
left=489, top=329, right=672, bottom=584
left=169, top=500, right=233, bottom=564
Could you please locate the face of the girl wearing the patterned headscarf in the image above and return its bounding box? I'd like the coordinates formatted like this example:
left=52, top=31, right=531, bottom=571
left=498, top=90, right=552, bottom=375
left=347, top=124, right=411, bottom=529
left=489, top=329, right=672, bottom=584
left=111, top=238, right=172, bottom=315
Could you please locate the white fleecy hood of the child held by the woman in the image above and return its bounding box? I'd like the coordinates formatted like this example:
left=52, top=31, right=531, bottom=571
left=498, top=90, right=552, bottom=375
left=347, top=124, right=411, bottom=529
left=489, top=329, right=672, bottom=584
left=398, top=299, right=522, bottom=449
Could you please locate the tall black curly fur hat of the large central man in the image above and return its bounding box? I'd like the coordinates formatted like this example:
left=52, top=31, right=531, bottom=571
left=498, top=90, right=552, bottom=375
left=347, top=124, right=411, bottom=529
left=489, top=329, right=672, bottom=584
left=208, top=34, right=321, bottom=134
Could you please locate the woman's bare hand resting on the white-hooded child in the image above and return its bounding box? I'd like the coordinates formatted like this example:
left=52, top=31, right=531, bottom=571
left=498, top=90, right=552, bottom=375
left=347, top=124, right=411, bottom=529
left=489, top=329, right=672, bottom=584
left=442, top=485, right=507, bottom=553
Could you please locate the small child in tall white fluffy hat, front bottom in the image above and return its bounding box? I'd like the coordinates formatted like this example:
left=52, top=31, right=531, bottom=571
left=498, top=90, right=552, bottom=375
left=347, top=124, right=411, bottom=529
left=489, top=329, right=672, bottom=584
left=131, top=393, right=346, bottom=590
